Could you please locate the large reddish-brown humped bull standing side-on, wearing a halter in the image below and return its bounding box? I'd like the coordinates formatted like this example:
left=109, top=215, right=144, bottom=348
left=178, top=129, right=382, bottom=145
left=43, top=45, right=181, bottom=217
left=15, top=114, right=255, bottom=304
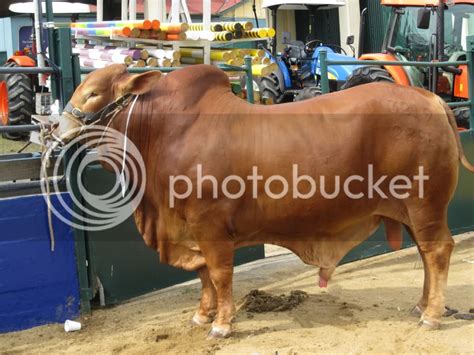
left=56, top=65, right=474, bottom=337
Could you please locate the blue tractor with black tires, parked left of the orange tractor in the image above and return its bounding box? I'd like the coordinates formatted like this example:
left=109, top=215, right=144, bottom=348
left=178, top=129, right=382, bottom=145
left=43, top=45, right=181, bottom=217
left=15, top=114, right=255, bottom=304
left=257, top=0, right=358, bottom=103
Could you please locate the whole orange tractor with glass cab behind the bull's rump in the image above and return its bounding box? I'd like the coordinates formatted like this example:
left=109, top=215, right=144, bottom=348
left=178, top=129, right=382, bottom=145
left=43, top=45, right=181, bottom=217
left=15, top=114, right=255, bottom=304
left=344, top=0, right=474, bottom=128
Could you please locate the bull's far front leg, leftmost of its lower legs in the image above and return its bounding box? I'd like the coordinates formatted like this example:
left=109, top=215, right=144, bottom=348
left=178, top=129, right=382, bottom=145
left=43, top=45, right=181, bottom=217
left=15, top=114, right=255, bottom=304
left=192, top=266, right=217, bottom=325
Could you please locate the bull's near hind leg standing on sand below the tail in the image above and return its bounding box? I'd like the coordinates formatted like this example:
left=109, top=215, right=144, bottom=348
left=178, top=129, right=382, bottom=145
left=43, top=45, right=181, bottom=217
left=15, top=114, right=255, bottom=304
left=412, top=212, right=454, bottom=328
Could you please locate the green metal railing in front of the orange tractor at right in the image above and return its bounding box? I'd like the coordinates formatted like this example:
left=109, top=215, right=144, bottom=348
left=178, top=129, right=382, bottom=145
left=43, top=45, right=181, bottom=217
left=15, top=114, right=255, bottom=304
left=319, top=36, right=474, bottom=130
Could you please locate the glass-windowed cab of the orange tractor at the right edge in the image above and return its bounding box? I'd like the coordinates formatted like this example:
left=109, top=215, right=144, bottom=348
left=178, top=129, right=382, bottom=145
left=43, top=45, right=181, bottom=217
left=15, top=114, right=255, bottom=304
left=382, top=1, right=474, bottom=90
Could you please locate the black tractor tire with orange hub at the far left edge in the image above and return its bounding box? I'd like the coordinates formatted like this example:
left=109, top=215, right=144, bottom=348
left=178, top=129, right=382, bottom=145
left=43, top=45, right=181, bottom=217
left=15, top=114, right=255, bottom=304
left=0, top=62, right=35, bottom=140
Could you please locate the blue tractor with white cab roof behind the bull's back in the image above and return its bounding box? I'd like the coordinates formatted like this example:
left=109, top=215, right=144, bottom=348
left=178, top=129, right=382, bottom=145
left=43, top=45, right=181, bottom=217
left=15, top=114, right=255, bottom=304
left=257, top=0, right=357, bottom=103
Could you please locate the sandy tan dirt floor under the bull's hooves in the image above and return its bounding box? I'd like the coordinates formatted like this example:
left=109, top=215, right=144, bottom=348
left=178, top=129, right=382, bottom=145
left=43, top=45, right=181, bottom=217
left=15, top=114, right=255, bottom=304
left=0, top=233, right=474, bottom=354
